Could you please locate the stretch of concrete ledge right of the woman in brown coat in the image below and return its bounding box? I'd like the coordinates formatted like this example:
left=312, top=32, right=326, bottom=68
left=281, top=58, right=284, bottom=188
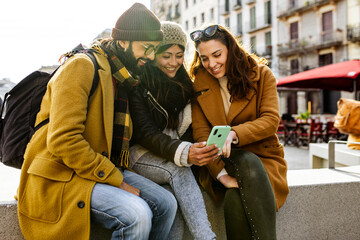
left=277, top=166, right=360, bottom=240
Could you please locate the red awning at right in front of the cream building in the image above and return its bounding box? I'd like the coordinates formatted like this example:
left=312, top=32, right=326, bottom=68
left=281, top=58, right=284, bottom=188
left=277, top=60, right=360, bottom=92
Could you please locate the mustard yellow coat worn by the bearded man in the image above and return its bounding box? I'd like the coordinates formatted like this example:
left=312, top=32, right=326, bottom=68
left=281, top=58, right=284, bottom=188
left=17, top=54, right=123, bottom=240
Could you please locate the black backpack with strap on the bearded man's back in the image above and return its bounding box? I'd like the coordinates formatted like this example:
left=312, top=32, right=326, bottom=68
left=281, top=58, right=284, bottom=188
left=0, top=44, right=99, bottom=169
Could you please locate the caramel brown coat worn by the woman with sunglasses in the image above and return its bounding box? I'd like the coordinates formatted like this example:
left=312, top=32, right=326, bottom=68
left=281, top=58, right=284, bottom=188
left=192, top=66, right=289, bottom=209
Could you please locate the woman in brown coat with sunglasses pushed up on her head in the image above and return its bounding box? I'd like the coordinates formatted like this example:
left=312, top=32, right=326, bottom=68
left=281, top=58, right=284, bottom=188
left=190, top=25, right=289, bottom=239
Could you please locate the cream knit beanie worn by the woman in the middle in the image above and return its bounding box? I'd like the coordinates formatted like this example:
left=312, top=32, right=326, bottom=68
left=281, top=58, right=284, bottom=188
left=157, top=21, right=187, bottom=49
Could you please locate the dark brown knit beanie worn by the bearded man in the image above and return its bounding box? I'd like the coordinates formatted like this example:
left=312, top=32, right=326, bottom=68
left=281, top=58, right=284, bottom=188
left=111, top=3, right=163, bottom=41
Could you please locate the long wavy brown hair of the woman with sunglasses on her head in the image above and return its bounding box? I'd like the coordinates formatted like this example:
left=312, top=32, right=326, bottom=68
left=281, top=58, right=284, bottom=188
left=190, top=25, right=266, bottom=100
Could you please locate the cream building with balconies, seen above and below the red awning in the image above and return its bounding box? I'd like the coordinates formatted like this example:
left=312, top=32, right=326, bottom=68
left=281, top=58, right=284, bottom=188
left=277, top=0, right=351, bottom=114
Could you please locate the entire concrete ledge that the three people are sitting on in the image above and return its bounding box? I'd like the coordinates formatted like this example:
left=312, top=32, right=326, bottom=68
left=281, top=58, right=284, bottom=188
left=0, top=166, right=360, bottom=240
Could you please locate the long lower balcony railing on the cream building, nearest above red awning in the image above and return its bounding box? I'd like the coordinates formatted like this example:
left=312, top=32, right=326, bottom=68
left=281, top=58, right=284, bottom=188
left=278, top=30, right=344, bottom=57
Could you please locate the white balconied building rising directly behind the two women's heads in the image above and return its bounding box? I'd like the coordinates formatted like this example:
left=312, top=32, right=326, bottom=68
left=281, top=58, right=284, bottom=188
left=151, top=0, right=277, bottom=71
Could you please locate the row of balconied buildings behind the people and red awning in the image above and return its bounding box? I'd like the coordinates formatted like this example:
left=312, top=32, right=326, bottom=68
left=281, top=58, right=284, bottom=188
left=151, top=0, right=360, bottom=118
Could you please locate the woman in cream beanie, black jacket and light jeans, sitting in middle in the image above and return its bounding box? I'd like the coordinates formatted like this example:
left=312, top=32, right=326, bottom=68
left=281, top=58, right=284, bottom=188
left=129, top=22, right=215, bottom=239
